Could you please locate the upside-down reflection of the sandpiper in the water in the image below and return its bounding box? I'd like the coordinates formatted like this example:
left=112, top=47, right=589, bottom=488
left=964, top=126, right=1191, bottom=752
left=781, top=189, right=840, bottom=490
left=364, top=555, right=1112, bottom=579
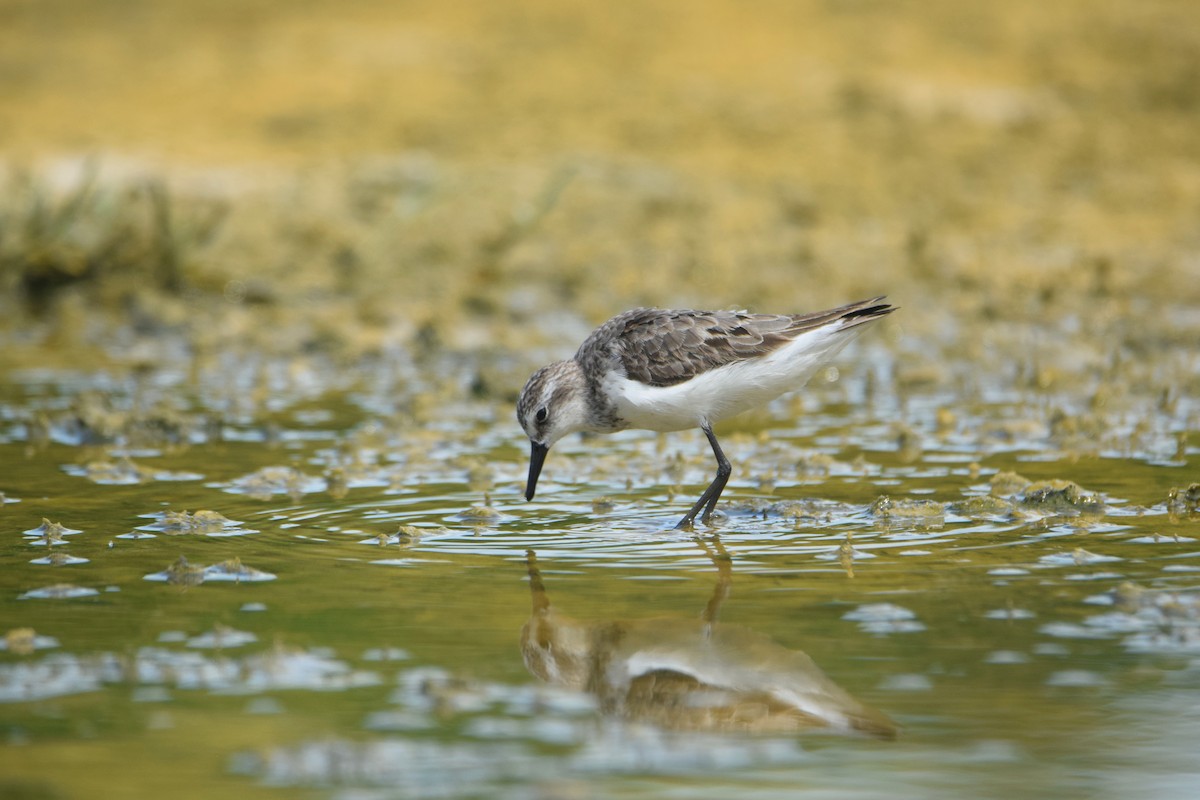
left=521, top=541, right=896, bottom=739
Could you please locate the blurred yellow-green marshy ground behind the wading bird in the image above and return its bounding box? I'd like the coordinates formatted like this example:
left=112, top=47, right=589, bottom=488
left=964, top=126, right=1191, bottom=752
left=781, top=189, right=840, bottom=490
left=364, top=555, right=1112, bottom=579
left=0, top=0, right=1200, bottom=392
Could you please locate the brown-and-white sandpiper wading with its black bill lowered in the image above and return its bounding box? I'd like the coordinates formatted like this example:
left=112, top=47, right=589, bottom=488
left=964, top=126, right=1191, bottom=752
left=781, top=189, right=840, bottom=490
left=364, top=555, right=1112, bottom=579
left=517, top=296, right=895, bottom=529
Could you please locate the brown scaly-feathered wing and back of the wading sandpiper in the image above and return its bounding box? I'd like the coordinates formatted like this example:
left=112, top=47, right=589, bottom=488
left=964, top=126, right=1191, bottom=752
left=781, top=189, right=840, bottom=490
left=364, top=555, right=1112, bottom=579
left=575, top=297, right=893, bottom=386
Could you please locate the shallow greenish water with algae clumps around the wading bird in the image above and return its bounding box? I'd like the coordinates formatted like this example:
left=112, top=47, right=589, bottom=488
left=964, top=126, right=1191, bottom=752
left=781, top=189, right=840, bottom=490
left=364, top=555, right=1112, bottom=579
left=0, top=350, right=1200, bottom=798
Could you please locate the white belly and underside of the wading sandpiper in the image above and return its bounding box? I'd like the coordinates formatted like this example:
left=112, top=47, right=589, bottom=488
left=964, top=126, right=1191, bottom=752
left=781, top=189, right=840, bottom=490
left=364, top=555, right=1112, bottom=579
left=605, top=327, right=862, bottom=431
